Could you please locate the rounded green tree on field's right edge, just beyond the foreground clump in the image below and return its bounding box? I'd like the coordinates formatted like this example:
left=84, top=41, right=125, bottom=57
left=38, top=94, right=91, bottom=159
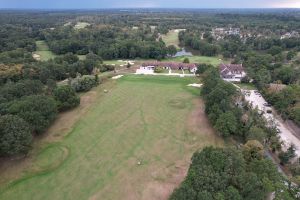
left=215, top=111, right=238, bottom=137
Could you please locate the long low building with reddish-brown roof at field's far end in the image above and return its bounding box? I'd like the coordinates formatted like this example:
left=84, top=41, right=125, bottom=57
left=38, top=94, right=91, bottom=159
left=136, top=61, right=197, bottom=74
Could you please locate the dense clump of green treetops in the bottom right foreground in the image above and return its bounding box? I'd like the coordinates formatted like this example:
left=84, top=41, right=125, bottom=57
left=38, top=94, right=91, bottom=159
left=170, top=147, right=286, bottom=200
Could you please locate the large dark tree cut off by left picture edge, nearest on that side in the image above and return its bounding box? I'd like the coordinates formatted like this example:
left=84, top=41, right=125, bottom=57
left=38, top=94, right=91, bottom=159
left=0, top=115, right=32, bottom=156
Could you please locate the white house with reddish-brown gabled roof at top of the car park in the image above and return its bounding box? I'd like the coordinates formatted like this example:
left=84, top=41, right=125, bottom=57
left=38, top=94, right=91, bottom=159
left=219, top=63, right=246, bottom=82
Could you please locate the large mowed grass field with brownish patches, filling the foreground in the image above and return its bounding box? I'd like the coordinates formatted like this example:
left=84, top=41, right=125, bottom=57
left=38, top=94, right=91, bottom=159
left=0, top=75, right=223, bottom=200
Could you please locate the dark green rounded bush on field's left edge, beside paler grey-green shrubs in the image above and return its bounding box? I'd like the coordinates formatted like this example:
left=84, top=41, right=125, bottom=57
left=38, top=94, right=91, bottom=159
left=53, top=85, right=80, bottom=111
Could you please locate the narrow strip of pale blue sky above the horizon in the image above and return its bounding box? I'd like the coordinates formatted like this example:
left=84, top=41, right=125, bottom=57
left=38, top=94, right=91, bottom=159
left=0, top=0, right=300, bottom=9
